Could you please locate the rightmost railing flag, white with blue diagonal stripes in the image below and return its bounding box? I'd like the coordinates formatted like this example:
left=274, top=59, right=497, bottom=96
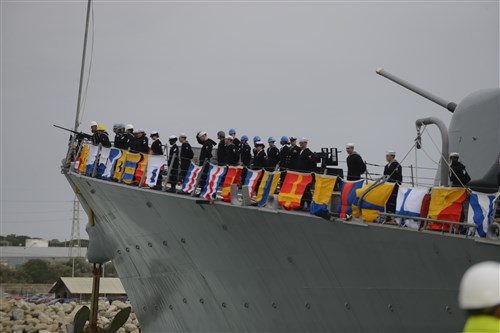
left=467, top=191, right=500, bottom=237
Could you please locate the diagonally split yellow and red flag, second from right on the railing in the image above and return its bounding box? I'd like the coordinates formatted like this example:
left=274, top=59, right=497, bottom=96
left=427, top=187, right=467, bottom=231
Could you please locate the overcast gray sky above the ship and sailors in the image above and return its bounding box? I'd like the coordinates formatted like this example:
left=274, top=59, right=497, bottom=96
left=0, top=0, right=500, bottom=240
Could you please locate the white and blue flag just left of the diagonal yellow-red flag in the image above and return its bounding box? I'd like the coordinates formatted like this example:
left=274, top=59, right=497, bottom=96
left=396, top=186, right=429, bottom=229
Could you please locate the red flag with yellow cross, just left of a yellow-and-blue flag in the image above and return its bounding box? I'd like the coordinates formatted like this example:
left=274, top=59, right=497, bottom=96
left=278, top=171, right=312, bottom=210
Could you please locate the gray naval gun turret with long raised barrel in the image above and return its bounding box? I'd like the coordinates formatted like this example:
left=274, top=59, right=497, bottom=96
left=376, top=68, right=500, bottom=193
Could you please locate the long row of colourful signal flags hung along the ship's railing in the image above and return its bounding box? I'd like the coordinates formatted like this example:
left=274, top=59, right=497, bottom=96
left=71, top=144, right=500, bottom=237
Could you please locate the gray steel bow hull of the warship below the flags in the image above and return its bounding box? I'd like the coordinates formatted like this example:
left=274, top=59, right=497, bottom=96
left=66, top=173, right=500, bottom=332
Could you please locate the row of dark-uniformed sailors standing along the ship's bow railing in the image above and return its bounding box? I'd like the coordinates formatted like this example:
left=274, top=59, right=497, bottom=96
left=91, top=122, right=470, bottom=186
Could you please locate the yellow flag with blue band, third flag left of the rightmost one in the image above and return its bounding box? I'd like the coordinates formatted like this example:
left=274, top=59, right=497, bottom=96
left=352, top=183, right=395, bottom=222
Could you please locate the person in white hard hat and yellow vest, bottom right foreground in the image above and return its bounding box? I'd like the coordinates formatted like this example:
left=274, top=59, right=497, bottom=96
left=458, top=261, right=500, bottom=333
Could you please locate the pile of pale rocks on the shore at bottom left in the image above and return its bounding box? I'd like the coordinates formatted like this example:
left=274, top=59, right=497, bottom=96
left=0, top=299, right=140, bottom=333
